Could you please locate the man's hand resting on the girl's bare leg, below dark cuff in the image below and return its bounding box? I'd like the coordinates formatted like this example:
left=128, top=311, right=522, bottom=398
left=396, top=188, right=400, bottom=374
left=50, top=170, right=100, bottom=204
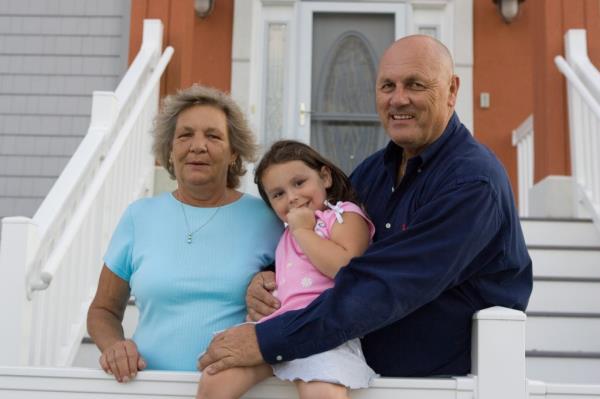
left=198, top=323, right=265, bottom=375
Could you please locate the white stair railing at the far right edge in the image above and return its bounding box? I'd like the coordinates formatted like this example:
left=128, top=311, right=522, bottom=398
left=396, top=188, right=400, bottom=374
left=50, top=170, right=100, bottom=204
left=554, top=29, right=600, bottom=233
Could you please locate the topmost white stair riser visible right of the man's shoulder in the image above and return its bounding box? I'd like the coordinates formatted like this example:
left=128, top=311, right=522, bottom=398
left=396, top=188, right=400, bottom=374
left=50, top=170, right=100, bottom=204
left=521, top=219, right=600, bottom=248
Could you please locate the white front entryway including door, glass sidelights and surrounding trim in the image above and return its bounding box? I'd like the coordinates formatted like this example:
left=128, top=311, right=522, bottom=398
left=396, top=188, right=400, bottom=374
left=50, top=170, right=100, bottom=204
left=231, top=0, right=473, bottom=187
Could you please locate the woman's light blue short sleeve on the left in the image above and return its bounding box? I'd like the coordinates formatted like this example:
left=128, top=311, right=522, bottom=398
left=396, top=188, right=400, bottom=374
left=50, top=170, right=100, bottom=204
left=104, top=206, right=134, bottom=282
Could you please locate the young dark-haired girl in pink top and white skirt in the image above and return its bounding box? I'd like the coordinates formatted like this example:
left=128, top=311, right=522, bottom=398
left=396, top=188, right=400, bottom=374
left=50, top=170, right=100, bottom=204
left=197, top=140, right=375, bottom=399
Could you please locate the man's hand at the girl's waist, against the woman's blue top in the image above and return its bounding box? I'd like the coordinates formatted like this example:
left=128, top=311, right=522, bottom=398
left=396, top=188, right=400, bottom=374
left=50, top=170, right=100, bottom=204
left=246, top=272, right=280, bottom=321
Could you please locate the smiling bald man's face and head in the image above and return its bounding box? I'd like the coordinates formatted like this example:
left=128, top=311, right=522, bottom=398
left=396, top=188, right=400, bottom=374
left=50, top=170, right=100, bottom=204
left=376, top=37, right=459, bottom=157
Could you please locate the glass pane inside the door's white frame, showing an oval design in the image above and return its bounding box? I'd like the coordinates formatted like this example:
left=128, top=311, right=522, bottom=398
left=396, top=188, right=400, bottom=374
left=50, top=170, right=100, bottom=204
left=310, top=13, right=394, bottom=174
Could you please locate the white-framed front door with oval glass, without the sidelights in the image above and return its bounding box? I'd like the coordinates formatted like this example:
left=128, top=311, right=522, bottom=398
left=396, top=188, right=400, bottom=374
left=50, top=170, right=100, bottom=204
left=291, top=2, right=406, bottom=173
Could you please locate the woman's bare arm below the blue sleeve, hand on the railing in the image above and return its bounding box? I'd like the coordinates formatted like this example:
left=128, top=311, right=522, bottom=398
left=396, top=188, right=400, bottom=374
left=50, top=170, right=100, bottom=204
left=87, top=265, right=146, bottom=382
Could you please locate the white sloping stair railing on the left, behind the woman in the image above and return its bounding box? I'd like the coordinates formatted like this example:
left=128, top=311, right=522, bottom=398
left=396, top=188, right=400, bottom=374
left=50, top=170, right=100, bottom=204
left=0, top=20, right=173, bottom=368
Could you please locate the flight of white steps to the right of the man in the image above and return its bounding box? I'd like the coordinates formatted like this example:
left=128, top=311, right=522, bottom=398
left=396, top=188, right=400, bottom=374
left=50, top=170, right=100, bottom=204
left=522, top=219, right=600, bottom=384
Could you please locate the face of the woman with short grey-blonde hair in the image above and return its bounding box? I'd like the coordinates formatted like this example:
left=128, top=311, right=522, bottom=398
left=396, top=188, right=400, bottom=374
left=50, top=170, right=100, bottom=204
left=171, top=105, right=236, bottom=187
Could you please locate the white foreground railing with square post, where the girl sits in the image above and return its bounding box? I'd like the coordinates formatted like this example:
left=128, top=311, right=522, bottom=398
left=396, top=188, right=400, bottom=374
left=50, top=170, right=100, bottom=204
left=0, top=307, right=528, bottom=399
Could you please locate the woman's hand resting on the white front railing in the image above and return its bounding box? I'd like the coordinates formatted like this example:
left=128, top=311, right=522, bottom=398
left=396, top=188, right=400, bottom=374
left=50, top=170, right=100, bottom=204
left=100, top=339, right=146, bottom=382
